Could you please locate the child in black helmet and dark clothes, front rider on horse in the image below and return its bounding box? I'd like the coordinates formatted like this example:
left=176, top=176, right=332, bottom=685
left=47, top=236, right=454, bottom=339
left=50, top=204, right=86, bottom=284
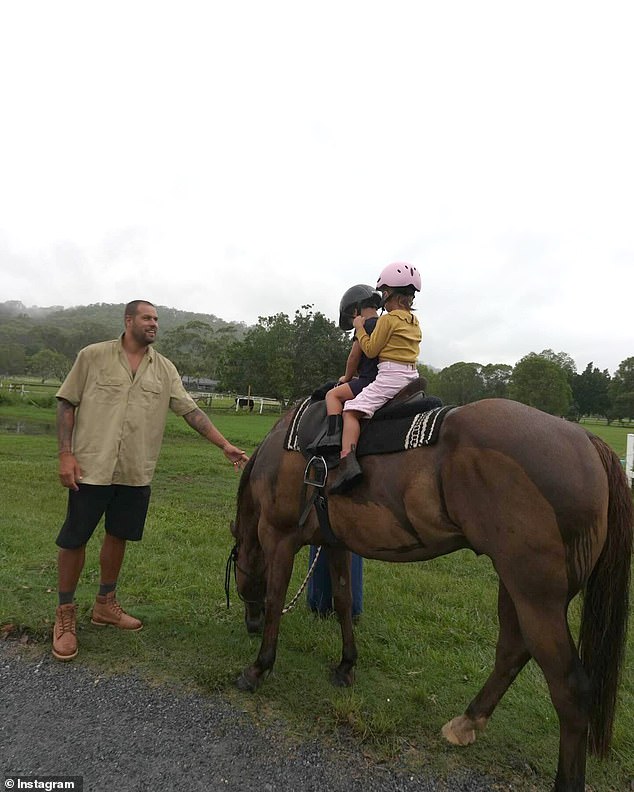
left=320, top=283, right=381, bottom=447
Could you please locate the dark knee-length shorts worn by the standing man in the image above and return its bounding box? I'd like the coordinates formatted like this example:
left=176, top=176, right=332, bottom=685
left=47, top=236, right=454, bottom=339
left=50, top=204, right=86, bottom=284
left=56, top=484, right=150, bottom=550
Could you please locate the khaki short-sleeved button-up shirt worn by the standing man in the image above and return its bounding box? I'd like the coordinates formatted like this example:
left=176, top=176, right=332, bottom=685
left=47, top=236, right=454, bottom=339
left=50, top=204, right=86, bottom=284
left=56, top=338, right=197, bottom=487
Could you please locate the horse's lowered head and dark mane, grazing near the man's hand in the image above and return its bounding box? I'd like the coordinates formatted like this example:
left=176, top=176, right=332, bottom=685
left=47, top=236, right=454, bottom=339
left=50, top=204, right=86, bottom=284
left=225, top=454, right=266, bottom=633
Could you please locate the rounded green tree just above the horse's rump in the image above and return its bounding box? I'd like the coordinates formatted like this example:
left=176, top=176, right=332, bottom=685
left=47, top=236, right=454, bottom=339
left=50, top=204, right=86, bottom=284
left=509, top=352, right=572, bottom=416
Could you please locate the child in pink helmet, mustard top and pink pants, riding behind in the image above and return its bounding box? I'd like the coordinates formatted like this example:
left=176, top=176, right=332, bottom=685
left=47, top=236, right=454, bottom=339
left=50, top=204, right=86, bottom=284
left=330, top=262, right=422, bottom=494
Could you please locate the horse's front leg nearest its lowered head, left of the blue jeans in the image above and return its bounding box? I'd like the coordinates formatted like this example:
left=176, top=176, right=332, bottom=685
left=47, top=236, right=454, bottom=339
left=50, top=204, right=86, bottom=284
left=237, top=536, right=295, bottom=692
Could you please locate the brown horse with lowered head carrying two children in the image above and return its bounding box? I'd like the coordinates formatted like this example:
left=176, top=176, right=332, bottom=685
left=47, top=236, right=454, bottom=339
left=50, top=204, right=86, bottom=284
left=232, top=399, right=632, bottom=792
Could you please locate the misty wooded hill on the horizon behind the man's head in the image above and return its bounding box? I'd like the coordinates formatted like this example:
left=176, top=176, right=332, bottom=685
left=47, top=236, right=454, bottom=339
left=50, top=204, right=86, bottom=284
left=0, top=300, right=248, bottom=338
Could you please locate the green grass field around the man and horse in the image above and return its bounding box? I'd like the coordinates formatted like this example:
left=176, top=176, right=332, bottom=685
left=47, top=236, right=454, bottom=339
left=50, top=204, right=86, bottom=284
left=0, top=404, right=634, bottom=792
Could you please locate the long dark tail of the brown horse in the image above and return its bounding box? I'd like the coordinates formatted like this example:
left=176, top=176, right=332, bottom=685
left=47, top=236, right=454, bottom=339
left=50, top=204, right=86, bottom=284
left=579, top=434, right=633, bottom=757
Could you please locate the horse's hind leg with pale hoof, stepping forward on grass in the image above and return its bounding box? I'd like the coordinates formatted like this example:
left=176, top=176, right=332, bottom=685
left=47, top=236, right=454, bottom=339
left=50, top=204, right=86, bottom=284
left=442, top=580, right=530, bottom=745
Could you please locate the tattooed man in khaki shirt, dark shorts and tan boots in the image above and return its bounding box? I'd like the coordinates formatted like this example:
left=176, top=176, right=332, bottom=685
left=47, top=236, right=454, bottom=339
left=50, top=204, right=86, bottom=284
left=53, top=300, right=247, bottom=660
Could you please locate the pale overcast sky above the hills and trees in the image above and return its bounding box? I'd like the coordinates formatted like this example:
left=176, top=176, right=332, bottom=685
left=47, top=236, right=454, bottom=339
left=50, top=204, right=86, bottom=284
left=0, top=0, right=634, bottom=373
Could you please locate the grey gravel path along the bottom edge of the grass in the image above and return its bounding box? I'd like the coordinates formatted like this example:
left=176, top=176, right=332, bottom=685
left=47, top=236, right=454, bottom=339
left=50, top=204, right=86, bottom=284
left=0, top=641, right=508, bottom=792
